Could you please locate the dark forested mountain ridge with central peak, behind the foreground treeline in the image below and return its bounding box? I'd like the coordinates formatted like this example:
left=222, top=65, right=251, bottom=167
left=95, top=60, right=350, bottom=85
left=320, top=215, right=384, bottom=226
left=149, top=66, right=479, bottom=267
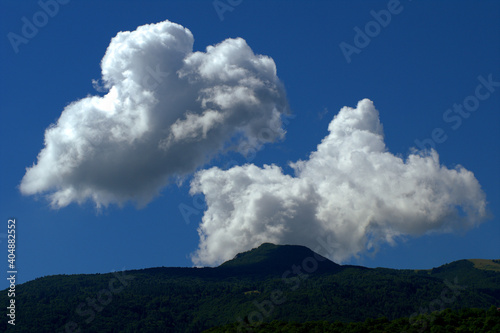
left=0, top=243, right=500, bottom=333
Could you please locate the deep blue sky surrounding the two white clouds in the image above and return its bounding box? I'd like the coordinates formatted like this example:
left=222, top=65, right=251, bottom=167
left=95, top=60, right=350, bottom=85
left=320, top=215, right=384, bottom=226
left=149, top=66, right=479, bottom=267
left=0, top=0, right=500, bottom=287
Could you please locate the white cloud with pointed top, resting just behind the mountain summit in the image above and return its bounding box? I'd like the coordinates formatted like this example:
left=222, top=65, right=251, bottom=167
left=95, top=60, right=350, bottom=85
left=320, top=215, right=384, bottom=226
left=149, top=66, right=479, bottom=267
left=191, top=99, right=486, bottom=265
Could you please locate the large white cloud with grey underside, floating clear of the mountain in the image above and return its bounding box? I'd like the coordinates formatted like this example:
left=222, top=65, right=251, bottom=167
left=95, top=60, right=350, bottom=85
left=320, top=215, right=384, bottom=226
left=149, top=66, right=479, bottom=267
left=20, top=21, right=288, bottom=207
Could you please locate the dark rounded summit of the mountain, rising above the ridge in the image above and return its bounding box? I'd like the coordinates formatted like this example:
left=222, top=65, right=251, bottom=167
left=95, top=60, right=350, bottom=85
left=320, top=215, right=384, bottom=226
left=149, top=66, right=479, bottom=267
left=219, top=243, right=340, bottom=274
